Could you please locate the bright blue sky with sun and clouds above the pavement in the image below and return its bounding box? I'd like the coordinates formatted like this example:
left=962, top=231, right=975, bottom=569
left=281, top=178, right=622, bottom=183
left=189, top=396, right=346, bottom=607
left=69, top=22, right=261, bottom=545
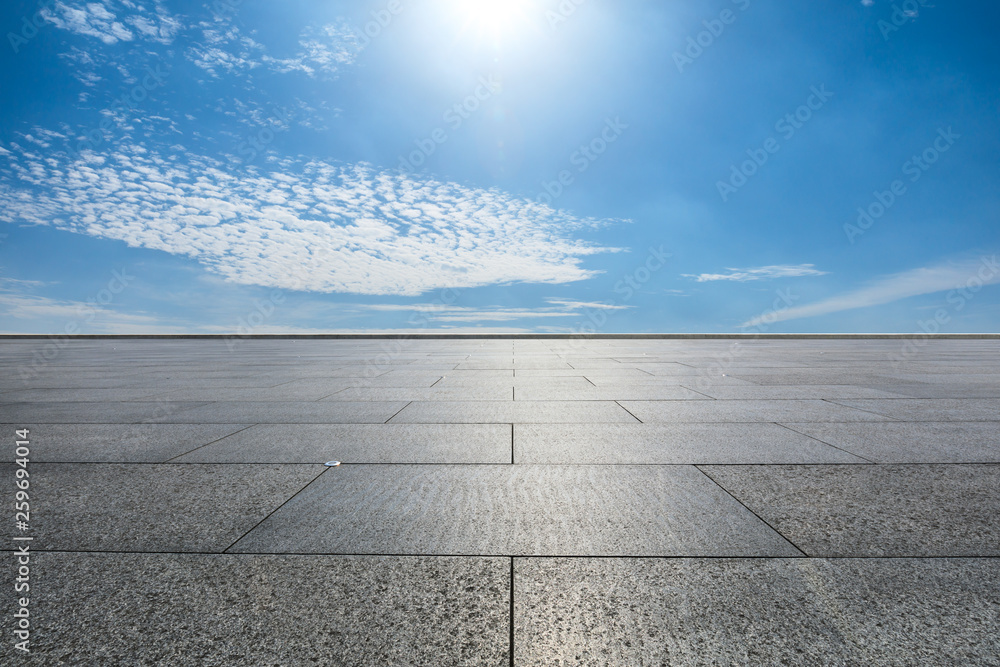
left=0, top=0, right=1000, bottom=334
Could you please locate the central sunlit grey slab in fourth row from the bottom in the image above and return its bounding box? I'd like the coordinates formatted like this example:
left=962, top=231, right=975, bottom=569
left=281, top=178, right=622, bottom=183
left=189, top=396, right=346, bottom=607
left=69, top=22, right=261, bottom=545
left=391, top=401, right=636, bottom=424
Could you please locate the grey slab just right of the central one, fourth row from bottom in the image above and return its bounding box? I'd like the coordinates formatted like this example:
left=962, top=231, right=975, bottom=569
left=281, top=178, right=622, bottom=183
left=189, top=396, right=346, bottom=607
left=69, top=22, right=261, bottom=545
left=621, top=400, right=893, bottom=423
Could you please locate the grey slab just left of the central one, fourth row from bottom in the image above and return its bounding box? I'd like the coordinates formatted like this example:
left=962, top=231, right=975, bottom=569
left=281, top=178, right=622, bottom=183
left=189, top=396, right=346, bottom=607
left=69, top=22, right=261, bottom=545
left=159, top=401, right=406, bottom=424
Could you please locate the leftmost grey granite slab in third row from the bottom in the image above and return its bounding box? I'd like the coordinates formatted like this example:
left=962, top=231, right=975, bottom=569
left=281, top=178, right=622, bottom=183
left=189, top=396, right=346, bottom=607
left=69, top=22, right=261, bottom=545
left=0, top=424, right=254, bottom=463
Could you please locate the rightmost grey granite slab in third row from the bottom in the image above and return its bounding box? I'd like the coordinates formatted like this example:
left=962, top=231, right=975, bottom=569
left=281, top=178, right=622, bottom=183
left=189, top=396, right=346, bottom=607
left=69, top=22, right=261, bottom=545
left=785, top=422, right=1000, bottom=463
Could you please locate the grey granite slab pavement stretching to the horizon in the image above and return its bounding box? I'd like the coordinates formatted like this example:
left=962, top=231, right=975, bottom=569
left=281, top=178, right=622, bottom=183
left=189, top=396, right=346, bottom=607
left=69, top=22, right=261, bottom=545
left=0, top=338, right=1000, bottom=666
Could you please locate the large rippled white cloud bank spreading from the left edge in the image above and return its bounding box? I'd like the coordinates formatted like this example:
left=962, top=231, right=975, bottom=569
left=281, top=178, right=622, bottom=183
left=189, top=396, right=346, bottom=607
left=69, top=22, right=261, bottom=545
left=0, top=143, right=618, bottom=296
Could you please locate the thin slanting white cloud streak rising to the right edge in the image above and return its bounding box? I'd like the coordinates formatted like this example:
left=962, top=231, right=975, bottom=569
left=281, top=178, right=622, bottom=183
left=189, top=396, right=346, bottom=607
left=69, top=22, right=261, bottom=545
left=740, top=255, right=1000, bottom=327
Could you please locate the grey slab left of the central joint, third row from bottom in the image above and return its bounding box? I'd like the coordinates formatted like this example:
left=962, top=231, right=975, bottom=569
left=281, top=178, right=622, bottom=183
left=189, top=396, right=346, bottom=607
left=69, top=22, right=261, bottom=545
left=176, top=424, right=511, bottom=464
